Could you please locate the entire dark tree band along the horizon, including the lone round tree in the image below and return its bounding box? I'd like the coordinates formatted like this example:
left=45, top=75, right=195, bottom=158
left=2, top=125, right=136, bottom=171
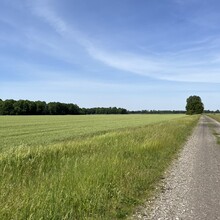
left=0, top=96, right=216, bottom=115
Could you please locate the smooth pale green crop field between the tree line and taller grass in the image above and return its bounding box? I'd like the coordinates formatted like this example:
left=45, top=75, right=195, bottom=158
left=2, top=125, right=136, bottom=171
left=0, top=115, right=186, bottom=151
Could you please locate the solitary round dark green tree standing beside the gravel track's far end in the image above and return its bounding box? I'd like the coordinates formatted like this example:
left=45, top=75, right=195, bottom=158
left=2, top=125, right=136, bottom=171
left=186, top=95, right=204, bottom=115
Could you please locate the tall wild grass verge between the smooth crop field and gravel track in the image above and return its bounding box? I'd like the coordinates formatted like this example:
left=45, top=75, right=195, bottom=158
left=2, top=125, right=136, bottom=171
left=0, top=116, right=198, bottom=219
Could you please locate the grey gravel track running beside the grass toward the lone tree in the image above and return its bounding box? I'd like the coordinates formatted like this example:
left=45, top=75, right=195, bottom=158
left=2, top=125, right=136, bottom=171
left=133, top=116, right=220, bottom=220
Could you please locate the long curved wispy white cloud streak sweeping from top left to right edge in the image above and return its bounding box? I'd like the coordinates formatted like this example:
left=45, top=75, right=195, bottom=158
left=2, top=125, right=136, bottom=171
left=26, top=1, right=220, bottom=83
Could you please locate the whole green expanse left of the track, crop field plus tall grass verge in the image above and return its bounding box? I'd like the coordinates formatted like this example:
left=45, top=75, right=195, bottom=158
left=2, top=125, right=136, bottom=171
left=0, top=115, right=199, bottom=219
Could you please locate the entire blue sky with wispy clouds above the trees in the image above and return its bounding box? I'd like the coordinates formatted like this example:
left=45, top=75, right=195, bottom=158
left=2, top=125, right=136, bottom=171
left=0, top=0, right=220, bottom=110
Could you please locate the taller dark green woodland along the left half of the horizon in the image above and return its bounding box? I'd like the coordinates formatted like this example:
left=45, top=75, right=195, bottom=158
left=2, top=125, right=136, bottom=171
left=0, top=99, right=128, bottom=115
